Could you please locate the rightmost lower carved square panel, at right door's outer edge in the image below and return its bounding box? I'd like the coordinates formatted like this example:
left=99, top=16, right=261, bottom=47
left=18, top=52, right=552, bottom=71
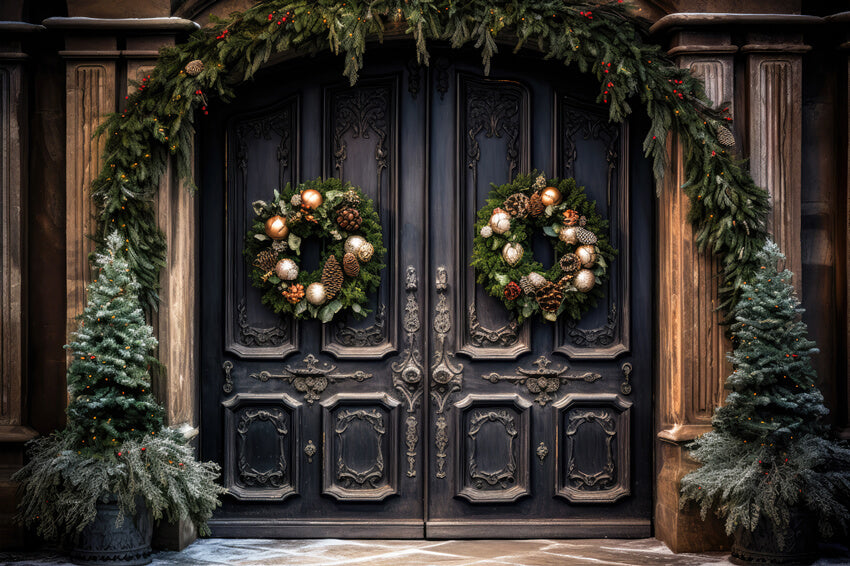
left=553, top=393, right=632, bottom=503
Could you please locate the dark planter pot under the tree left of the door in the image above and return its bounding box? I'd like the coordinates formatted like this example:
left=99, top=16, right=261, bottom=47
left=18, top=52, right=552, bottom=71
left=71, top=497, right=153, bottom=566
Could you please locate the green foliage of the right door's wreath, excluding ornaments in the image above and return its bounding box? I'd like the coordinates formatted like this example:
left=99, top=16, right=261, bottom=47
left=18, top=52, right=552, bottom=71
left=471, top=171, right=617, bottom=322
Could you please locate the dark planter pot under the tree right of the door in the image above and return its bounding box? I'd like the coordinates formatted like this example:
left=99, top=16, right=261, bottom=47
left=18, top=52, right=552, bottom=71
left=731, top=511, right=818, bottom=564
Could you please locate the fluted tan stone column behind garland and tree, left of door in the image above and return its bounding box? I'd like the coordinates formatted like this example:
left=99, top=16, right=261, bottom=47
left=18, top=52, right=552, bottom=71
left=44, top=16, right=199, bottom=549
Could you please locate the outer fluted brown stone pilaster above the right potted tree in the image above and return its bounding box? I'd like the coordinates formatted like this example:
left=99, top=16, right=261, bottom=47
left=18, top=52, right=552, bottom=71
left=741, top=31, right=811, bottom=296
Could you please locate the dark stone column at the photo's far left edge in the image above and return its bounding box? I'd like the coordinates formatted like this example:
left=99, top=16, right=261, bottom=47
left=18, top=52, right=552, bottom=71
left=0, top=22, right=44, bottom=548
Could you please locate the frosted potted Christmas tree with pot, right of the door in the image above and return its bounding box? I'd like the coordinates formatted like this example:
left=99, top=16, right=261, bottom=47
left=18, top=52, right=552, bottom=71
left=682, top=242, right=850, bottom=564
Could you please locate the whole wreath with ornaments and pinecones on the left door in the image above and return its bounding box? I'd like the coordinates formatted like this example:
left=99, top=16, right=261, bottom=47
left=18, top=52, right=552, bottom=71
left=243, top=179, right=386, bottom=322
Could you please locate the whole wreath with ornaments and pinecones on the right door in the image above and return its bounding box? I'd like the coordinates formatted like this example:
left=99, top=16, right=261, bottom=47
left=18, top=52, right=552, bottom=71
left=472, top=172, right=616, bottom=322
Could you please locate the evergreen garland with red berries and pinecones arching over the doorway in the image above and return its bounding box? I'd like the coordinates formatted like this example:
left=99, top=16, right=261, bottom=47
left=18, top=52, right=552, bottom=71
left=92, top=0, right=769, bottom=322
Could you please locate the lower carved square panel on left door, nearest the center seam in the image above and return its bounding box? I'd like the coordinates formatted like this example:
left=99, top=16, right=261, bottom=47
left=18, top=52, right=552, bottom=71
left=321, top=393, right=400, bottom=501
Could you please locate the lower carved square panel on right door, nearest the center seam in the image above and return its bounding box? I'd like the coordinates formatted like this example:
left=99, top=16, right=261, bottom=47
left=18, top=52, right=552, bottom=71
left=453, top=393, right=532, bottom=503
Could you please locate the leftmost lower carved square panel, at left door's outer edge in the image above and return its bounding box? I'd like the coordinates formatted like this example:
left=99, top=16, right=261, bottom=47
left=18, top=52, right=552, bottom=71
left=222, top=393, right=301, bottom=501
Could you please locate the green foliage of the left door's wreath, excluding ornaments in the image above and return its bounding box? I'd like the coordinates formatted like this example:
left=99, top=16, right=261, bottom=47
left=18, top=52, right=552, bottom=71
left=243, top=182, right=387, bottom=322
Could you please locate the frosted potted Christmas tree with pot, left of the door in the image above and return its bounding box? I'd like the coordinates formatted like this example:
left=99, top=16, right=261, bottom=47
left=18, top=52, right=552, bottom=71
left=14, top=233, right=224, bottom=564
